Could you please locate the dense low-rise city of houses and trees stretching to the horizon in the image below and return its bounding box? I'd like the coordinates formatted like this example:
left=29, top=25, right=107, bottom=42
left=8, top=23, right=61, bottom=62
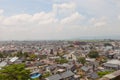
left=0, top=40, right=120, bottom=80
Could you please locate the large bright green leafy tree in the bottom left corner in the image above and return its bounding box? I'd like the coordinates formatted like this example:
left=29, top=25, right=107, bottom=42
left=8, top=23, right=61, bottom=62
left=0, top=64, right=30, bottom=80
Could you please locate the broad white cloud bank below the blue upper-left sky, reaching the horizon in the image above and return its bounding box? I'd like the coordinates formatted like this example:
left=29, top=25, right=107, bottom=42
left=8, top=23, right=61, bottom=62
left=0, top=0, right=120, bottom=40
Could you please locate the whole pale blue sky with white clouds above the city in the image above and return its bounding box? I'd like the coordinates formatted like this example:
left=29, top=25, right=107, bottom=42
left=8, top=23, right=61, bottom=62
left=0, top=0, right=120, bottom=40
